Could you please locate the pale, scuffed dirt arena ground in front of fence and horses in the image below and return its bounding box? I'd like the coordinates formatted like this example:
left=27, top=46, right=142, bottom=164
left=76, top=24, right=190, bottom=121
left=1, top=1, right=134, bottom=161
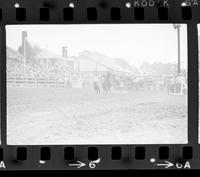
left=7, top=88, right=187, bottom=145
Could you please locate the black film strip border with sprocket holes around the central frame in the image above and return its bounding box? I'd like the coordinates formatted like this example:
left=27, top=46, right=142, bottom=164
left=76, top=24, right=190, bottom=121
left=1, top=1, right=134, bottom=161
left=0, top=0, right=200, bottom=170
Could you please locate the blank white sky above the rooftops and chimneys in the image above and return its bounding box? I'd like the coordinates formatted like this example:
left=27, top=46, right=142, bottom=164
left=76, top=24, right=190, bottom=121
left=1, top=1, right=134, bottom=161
left=6, top=24, right=187, bottom=68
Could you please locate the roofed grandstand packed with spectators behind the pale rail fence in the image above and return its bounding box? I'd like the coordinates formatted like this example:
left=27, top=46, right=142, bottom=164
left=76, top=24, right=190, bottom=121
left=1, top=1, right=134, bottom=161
left=7, top=47, right=72, bottom=87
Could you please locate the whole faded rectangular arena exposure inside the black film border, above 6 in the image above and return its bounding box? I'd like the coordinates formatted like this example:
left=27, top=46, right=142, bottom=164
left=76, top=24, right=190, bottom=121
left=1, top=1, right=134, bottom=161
left=6, top=24, right=188, bottom=145
